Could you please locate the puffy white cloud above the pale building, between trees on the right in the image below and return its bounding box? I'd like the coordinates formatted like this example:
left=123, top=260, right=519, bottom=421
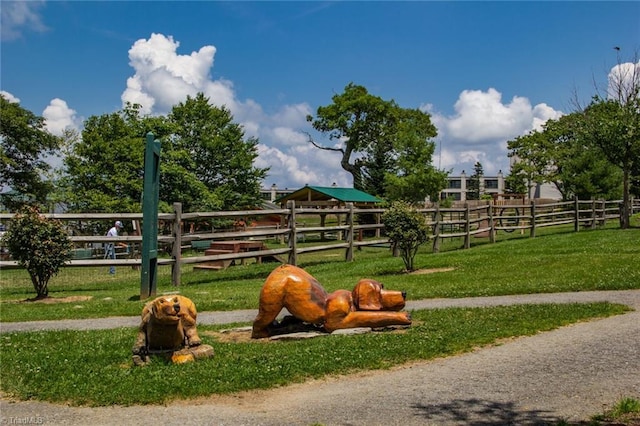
left=422, top=88, right=562, bottom=175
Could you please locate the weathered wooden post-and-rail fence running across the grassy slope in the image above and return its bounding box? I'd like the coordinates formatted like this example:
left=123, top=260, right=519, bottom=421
left=0, top=199, right=640, bottom=285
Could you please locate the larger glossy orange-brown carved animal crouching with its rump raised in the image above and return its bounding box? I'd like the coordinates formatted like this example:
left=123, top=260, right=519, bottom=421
left=251, top=265, right=411, bottom=339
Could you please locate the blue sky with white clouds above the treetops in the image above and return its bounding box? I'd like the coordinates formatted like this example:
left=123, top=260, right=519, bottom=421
left=0, top=0, right=640, bottom=188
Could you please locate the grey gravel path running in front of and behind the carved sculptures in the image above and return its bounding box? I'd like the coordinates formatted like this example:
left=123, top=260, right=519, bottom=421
left=0, top=290, right=640, bottom=425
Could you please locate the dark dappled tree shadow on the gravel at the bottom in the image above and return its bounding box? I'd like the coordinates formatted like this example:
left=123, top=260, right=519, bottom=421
left=412, top=398, right=566, bottom=426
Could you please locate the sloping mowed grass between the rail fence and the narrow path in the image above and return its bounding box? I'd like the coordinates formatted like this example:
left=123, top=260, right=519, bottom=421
left=0, top=228, right=640, bottom=322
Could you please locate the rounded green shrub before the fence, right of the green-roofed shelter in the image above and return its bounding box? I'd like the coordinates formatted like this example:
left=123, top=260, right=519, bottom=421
left=382, top=201, right=429, bottom=271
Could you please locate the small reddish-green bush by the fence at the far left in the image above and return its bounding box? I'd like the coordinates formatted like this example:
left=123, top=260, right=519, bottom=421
left=2, top=206, right=73, bottom=299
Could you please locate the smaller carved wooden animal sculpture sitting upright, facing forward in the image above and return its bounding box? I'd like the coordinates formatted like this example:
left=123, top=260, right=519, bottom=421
left=133, top=295, right=202, bottom=362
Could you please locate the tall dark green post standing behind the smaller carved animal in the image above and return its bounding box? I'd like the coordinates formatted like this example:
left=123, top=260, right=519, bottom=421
left=140, top=133, right=160, bottom=300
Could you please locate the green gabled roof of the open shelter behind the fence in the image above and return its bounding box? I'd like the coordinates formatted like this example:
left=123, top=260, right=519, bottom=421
left=275, top=185, right=382, bottom=208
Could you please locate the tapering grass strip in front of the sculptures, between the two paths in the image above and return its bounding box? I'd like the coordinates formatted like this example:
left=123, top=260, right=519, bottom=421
left=0, top=303, right=628, bottom=406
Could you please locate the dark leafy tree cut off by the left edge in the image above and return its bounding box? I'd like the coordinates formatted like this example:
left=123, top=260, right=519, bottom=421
left=0, top=95, right=60, bottom=211
